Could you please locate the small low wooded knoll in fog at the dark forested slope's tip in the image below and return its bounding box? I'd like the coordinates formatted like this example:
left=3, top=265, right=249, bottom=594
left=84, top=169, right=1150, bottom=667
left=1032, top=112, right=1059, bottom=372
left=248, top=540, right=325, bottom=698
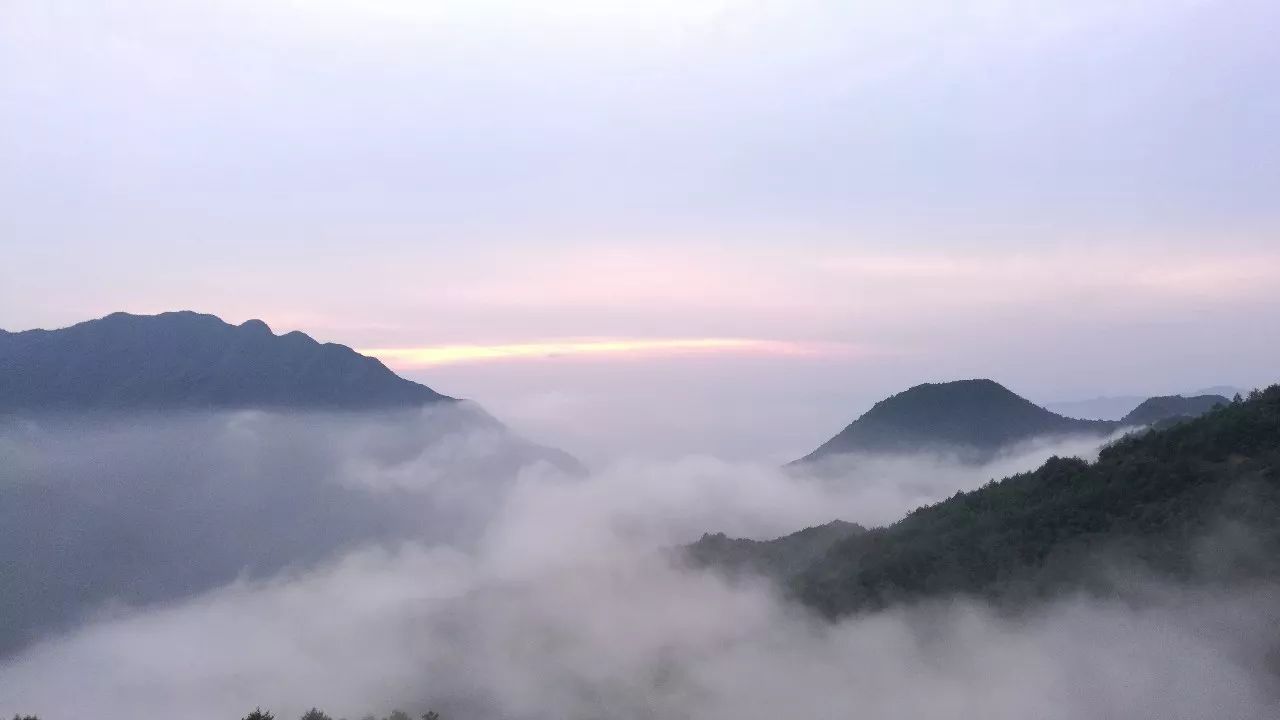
left=681, top=520, right=867, bottom=579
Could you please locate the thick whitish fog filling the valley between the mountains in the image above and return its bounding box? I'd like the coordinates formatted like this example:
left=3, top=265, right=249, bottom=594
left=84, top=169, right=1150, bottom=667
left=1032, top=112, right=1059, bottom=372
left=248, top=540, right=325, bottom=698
left=0, top=418, right=1280, bottom=720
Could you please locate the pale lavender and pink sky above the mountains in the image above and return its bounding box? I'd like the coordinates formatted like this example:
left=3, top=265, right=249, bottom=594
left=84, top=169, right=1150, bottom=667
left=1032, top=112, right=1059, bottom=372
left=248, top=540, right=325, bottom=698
left=0, top=0, right=1280, bottom=461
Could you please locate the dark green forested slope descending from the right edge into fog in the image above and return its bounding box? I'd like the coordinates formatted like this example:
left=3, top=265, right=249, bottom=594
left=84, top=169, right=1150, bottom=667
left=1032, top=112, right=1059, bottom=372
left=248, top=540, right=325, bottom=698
left=790, top=386, right=1280, bottom=616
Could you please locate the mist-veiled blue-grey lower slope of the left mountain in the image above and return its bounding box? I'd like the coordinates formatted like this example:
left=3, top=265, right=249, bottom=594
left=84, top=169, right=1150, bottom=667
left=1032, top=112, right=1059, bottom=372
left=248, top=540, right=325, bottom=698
left=0, top=404, right=565, bottom=655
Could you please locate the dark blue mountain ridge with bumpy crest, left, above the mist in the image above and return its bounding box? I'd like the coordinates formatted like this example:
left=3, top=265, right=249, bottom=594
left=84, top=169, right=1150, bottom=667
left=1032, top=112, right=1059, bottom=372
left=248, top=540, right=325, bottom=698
left=0, top=311, right=453, bottom=413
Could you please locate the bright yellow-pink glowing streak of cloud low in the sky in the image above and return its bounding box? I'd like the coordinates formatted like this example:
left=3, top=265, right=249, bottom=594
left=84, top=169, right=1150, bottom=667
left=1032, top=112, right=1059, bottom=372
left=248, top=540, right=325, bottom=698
left=360, top=337, right=834, bottom=368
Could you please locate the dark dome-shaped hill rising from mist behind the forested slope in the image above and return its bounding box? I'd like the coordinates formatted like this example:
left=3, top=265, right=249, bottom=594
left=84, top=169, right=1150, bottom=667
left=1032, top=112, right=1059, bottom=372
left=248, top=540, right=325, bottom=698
left=799, top=379, right=1117, bottom=462
